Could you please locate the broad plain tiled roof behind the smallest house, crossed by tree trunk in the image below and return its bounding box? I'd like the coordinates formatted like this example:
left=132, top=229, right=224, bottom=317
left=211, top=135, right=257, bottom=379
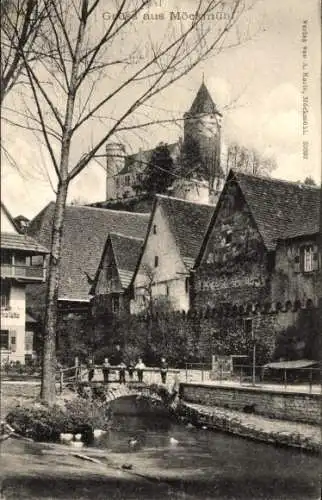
left=28, top=203, right=149, bottom=301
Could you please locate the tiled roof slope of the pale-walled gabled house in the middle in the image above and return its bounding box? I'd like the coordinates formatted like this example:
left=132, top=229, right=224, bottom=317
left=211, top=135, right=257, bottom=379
left=157, top=195, right=214, bottom=269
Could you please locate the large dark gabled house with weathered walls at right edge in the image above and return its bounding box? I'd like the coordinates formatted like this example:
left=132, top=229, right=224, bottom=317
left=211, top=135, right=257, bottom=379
left=193, top=171, right=322, bottom=359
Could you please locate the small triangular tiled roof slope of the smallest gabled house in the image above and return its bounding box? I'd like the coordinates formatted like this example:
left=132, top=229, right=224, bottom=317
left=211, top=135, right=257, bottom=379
left=110, top=233, right=143, bottom=288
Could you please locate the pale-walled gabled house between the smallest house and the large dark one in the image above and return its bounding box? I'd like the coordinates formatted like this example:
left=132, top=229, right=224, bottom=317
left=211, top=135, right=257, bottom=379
left=131, top=195, right=214, bottom=313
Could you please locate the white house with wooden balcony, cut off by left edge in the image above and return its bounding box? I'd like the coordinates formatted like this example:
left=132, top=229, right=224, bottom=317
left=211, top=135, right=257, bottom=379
left=0, top=202, right=48, bottom=364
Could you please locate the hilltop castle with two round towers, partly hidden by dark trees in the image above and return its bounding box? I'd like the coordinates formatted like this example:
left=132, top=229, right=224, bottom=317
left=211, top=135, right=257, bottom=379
left=106, top=82, right=224, bottom=204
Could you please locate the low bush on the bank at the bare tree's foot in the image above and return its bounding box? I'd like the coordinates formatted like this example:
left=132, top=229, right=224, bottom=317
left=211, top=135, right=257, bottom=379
left=6, top=398, right=110, bottom=443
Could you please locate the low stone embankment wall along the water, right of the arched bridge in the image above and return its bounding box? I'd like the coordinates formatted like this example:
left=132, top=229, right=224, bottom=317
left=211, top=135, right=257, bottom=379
left=180, top=383, right=321, bottom=425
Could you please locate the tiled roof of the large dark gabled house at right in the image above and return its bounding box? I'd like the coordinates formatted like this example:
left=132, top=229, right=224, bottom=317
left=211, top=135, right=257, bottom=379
left=234, top=172, right=320, bottom=250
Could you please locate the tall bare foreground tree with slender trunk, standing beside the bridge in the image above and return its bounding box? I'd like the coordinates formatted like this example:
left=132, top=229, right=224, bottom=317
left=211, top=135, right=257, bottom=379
left=7, top=0, right=253, bottom=403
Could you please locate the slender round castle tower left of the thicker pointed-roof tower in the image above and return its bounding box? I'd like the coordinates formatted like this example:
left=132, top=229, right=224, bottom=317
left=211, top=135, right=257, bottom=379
left=106, top=142, right=126, bottom=200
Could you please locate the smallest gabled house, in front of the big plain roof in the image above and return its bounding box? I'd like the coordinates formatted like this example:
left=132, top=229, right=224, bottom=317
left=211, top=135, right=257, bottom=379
left=90, top=233, right=143, bottom=315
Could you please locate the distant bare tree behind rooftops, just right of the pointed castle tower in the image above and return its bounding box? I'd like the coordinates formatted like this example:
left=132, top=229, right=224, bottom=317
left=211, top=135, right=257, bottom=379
left=224, top=142, right=277, bottom=176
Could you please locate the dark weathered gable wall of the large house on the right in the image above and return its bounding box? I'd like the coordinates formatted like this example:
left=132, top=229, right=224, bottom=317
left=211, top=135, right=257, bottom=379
left=194, top=182, right=270, bottom=308
